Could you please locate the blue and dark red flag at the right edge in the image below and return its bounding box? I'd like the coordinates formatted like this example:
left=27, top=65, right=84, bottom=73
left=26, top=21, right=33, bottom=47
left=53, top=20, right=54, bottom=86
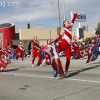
left=86, top=39, right=100, bottom=63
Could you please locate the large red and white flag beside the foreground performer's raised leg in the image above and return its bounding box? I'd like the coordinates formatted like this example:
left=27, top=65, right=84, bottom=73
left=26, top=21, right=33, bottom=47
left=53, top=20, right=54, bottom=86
left=43, top=43, right=64, bottom=76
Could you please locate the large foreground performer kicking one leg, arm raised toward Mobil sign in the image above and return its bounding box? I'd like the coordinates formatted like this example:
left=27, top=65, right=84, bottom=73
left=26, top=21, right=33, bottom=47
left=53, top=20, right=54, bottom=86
left=55, top=13, right=76, bottom=77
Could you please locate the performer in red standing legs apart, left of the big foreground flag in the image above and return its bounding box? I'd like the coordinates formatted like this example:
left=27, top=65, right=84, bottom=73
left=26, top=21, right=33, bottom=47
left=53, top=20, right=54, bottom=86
left=32, top=37, right=42, bottom=67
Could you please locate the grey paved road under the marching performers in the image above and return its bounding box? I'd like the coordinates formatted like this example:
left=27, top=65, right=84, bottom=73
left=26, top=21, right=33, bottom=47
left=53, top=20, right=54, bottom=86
left=0, top=57, right=100, bottom=100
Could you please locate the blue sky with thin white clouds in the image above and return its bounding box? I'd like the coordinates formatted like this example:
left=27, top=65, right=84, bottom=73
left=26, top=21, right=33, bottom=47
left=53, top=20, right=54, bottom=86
left=0, top=0, right=100, bottom=33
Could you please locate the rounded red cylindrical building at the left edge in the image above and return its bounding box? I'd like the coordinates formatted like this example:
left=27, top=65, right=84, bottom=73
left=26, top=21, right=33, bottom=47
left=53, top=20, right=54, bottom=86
left=0, top=23, right=16, bottom=47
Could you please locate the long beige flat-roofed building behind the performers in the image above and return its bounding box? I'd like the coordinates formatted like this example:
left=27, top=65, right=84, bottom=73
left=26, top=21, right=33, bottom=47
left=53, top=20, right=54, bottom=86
left=13, top=28, right=95, bottom=51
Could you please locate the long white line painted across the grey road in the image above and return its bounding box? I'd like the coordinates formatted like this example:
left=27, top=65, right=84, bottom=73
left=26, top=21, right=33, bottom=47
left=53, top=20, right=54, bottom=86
left=3, top=72, right=100, bottom=83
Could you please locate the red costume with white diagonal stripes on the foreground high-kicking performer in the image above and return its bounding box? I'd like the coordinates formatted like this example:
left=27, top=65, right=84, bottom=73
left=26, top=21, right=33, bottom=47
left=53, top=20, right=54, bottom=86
left=55, top=14, right=76, bottom=72
